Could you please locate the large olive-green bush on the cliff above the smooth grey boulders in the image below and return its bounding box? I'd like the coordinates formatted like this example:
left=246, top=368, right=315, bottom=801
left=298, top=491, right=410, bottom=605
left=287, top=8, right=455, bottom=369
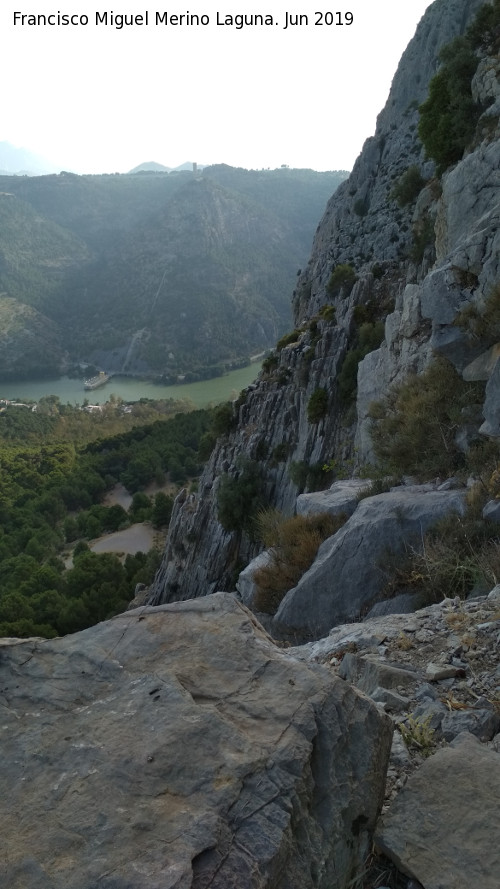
left=369, top=358, right=484, bottom=478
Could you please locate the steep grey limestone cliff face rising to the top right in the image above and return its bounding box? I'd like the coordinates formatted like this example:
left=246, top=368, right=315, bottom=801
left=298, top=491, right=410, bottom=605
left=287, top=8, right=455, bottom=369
left=151, top=0, right=500, bottom=603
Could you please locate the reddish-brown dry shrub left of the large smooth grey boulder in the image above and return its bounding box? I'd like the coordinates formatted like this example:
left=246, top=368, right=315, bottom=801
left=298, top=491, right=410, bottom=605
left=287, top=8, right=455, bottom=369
left=254, top=510, right=346, bottom=614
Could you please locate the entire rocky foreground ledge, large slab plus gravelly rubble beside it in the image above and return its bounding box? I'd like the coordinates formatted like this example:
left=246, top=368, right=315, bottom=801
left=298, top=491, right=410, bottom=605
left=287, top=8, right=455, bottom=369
left=0, top=586, right=500, bottom=889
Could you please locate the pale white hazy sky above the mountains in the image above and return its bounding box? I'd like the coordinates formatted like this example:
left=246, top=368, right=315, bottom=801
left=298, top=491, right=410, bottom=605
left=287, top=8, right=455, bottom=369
left=0, top=0, right=429, bottom=173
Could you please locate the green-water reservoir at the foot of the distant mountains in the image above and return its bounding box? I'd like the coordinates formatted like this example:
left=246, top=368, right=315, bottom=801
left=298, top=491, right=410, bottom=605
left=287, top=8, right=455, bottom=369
left=0, top=361, right=261, bottom=408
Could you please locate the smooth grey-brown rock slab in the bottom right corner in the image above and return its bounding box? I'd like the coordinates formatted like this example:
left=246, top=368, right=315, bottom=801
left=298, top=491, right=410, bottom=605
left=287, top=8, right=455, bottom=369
left=376, top=733, right=500, bottom=889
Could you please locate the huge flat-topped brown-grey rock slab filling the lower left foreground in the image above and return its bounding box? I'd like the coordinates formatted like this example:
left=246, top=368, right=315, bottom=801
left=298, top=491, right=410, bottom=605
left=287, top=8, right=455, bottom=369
left=0, top=593, right=392, bottom=889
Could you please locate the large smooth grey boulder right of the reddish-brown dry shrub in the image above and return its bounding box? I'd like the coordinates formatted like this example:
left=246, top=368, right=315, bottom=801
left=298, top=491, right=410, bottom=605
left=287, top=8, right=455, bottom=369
left=273, top=486, right=465, bottom=639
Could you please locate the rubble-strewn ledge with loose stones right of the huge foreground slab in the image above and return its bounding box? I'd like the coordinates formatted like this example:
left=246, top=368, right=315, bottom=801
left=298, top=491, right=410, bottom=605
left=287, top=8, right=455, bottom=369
left=289, top=586, right=500, bottom=889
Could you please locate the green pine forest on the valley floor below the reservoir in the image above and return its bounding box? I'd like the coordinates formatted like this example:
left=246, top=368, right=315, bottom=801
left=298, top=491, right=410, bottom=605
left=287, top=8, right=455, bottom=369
left=0, top=396, right=214, bottom=637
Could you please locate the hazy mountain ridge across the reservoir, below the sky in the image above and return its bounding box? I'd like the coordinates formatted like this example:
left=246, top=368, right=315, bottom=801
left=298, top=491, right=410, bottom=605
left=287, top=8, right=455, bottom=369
left=0, top=164, right=347, bottom=380
